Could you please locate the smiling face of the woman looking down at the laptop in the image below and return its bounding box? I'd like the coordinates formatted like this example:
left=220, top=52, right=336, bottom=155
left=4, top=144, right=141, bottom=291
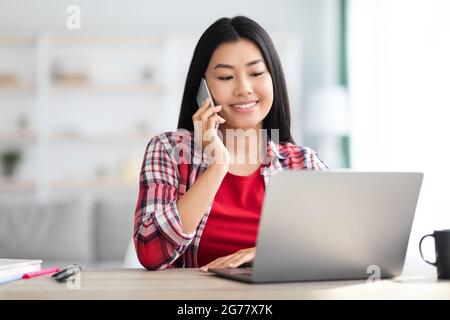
left=205, top=39, right=273, bottom=129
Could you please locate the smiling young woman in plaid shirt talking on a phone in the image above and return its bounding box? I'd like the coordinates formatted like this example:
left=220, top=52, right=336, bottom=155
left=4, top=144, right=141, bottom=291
left=134, top=16, right=327, bottom=271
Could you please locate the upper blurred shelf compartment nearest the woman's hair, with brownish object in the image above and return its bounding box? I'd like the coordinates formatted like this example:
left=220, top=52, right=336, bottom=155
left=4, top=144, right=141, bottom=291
left=48, top=34, right=166, bottom=96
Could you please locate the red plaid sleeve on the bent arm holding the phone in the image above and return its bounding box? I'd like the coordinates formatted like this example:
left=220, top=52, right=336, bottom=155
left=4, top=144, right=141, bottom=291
left=134, top=136, right=195, bottom=270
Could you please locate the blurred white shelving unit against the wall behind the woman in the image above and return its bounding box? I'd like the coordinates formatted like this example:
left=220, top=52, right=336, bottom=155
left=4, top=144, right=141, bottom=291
left=0, top=32, right=190, bottom=197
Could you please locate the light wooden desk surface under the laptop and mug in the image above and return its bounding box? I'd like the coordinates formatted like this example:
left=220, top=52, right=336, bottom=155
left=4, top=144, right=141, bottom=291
left=0, top=269, right=450, bottom=300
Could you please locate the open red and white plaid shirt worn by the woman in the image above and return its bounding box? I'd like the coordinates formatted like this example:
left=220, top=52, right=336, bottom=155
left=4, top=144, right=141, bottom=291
left=134, top=130, right=328, bottom=270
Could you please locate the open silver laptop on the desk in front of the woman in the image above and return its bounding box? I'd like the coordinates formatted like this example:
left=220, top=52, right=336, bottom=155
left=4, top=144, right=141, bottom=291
left=209, top=171, right=423, bottom=283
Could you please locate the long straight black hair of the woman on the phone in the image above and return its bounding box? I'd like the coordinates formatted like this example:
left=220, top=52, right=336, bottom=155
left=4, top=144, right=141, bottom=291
left=178, top=16, right=294, bottom=143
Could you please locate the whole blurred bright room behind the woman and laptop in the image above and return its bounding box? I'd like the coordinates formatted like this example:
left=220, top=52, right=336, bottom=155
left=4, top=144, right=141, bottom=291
left=0, top=0, right=450, bottom=267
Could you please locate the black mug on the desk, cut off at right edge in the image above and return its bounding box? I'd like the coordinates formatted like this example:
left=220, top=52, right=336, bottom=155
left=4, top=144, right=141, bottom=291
left=419, top=230, right=450, bottom=279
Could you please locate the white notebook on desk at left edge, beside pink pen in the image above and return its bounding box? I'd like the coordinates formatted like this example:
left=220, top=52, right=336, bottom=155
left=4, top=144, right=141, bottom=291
left=0, top=259, right=42, bottom=284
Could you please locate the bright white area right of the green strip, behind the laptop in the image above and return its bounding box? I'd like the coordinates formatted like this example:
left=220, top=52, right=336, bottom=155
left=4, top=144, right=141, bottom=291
left=349, top=0, right=450, bottom=265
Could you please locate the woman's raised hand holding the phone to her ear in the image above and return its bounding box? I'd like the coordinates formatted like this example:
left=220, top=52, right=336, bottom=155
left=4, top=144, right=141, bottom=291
left=192, top=98, right=230, bottom=167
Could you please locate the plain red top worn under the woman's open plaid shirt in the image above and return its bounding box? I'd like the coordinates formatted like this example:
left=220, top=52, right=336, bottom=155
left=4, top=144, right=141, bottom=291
left=197, top=166, right=265, bottom=266
